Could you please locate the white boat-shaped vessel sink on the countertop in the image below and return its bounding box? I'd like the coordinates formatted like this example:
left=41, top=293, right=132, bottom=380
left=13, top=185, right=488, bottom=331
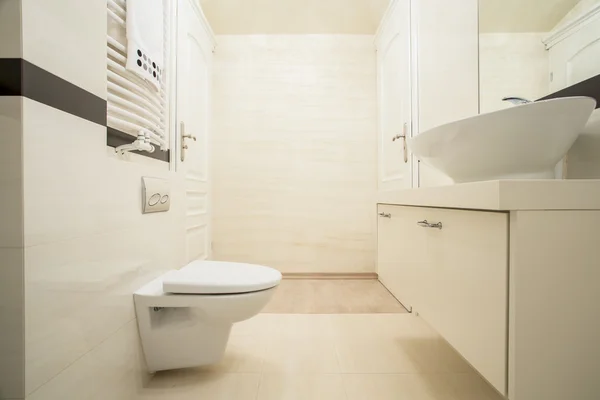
left=408, top=97, right=596, bottom=183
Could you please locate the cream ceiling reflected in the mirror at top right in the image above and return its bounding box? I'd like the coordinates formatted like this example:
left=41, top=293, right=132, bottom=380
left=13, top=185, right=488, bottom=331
left=479, top=0, right=580, bottom=33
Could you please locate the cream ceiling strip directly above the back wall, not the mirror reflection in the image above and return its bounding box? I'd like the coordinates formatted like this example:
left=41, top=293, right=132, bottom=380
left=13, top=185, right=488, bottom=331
left=199, top=0, right=389, bottom=34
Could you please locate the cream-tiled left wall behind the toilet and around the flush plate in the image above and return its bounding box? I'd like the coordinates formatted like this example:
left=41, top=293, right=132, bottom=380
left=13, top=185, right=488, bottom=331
left=0, top=0, right=184, bottom=400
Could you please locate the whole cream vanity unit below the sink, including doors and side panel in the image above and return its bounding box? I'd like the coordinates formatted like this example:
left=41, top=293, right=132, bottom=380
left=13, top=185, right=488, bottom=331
left=377, top=186, right=600, bottom=400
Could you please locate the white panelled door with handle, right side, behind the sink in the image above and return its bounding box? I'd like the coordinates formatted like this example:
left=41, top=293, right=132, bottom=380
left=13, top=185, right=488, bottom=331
left=376, top=0, right=412, bottom=190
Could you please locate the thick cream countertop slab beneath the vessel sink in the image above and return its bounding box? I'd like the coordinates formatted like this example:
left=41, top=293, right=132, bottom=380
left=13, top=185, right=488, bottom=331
left=377, top=179, right=600, bottom=211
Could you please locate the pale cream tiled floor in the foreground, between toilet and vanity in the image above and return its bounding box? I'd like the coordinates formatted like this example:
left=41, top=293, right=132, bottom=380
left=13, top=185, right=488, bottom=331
left=139, top=314, right=502, bottom=400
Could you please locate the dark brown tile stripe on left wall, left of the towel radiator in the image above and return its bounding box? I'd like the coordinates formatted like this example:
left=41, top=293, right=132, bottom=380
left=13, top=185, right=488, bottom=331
left=0, top=58, right=106, bottom=126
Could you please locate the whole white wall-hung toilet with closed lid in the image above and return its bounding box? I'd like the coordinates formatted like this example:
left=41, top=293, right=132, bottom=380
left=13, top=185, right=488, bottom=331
left=133, top=261, right=281, bottom=372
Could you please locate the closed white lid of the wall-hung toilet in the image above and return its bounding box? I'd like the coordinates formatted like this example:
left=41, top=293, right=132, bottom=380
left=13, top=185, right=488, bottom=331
left=163, top=261, right=281, bottom=294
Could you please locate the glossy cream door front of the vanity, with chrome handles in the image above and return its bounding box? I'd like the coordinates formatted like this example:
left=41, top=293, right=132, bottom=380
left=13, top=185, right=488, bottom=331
left=378, top=205, right=508, bottom=393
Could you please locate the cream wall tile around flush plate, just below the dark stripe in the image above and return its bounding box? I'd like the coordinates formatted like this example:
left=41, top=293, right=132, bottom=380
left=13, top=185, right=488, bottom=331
left=23, top=98, right=175, bottom=246
